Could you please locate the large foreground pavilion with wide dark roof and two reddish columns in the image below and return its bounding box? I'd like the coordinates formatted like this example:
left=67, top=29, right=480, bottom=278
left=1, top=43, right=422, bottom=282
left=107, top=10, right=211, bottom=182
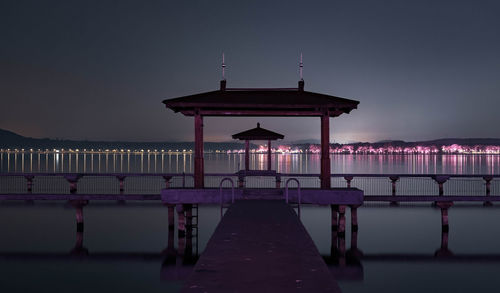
left=163, top=79, right=359, bottom=189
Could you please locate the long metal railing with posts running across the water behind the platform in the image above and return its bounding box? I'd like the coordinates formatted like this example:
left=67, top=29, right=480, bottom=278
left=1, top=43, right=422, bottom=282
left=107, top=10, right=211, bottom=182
left=0, top=173, right=500, bottom=196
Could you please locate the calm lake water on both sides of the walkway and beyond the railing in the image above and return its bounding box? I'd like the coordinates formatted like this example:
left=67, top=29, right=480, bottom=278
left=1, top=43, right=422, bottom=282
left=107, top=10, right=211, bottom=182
left=0, top=153, right=500, bottom=292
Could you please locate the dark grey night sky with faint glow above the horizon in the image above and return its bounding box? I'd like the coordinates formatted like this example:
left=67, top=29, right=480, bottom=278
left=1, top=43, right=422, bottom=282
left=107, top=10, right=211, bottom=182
left=0, top=0, right=500, bottom=142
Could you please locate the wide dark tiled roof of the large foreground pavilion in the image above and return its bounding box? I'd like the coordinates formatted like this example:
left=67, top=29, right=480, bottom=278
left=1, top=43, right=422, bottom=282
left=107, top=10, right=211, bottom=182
left=163, top=82, right=359, bottom=117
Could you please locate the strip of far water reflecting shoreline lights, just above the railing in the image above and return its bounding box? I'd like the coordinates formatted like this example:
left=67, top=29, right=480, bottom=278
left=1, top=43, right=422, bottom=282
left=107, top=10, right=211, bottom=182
left=0, top=150, right=500, bottom=174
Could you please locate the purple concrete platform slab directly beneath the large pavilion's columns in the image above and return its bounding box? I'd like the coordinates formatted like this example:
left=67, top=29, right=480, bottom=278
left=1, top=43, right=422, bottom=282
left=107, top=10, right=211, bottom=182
left=161, top=188, right=363, bottom=205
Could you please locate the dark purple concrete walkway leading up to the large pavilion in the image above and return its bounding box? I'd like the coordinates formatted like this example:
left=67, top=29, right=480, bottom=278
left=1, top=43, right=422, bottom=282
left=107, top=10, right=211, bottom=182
left=182, top=200, right=341, bottom=293
